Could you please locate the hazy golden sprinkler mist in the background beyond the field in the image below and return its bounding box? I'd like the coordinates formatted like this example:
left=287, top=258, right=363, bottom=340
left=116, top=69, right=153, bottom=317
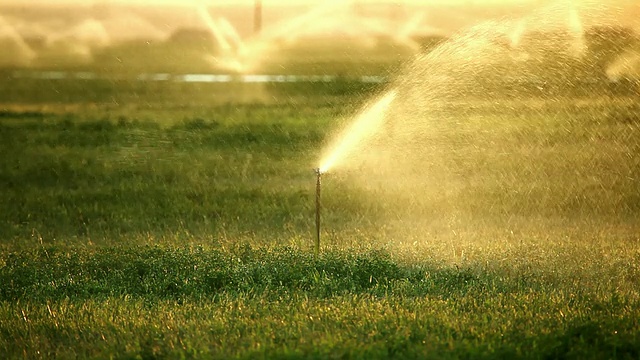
left=0, top=1, right=638, bottom=75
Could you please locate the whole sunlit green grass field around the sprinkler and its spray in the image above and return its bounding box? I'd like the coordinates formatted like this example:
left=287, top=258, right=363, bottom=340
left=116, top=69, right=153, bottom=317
left=0, top=82, right=640, bottom=359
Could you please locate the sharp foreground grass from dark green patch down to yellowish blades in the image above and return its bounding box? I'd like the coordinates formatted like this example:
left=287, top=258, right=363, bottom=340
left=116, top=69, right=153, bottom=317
left=0, top=244, right=640, bottom=358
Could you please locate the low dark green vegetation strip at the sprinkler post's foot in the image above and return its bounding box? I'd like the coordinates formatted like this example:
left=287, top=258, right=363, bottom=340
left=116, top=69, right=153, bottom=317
left=0, top=244, right=404, bottom=303
